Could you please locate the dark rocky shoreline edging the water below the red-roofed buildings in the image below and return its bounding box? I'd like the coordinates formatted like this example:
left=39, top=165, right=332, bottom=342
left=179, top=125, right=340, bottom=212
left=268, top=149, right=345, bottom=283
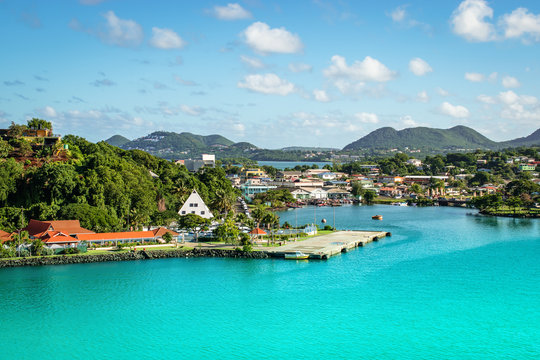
left=0, top=249, right=269, bottom=268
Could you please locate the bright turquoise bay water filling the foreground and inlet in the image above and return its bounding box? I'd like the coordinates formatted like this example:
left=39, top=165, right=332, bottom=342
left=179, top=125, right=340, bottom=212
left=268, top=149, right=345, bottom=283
left=0, top=206, right=540, bottom=359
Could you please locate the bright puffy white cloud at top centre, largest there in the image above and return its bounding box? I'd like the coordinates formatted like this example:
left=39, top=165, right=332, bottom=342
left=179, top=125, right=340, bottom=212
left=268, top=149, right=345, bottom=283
left=242, top=21, right=304, bottom=54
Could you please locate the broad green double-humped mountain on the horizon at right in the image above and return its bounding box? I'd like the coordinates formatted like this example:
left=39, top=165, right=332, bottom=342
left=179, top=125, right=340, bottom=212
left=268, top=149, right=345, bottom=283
left=343, top=126, right=500, bottom=151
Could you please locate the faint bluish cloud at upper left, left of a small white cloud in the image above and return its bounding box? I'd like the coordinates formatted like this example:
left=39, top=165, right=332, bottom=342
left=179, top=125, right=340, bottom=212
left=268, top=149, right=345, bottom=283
left=99, top=11, right=144, bottom=47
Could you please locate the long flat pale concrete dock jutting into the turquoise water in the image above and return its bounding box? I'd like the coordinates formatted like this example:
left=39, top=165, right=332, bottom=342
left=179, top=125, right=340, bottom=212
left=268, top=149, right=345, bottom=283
left=264, top=231, right=391, bottom=259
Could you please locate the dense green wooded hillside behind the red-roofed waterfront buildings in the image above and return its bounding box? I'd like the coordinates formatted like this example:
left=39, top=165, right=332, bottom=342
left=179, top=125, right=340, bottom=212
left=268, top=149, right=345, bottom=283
left=0, top=135, right=236, bottom=231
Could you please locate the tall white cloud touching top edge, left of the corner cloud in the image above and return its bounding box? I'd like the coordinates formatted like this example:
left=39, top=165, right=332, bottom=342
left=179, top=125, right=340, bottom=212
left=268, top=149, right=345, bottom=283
left=450, top=0, right=495, bottom=42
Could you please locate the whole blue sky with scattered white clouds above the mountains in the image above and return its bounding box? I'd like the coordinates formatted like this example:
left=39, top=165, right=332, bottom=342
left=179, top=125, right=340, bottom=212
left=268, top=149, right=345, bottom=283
left=0, top=0, right=540, bottom=148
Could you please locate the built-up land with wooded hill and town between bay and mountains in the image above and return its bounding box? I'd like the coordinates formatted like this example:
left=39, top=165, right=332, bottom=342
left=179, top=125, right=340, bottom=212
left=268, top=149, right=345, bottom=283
left=0, top=118, right=540, bottom=257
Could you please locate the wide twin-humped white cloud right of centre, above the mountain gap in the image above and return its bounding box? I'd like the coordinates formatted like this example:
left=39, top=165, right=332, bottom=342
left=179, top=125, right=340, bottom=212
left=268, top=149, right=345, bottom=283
left=323, top=55, right=396, bottom=82
